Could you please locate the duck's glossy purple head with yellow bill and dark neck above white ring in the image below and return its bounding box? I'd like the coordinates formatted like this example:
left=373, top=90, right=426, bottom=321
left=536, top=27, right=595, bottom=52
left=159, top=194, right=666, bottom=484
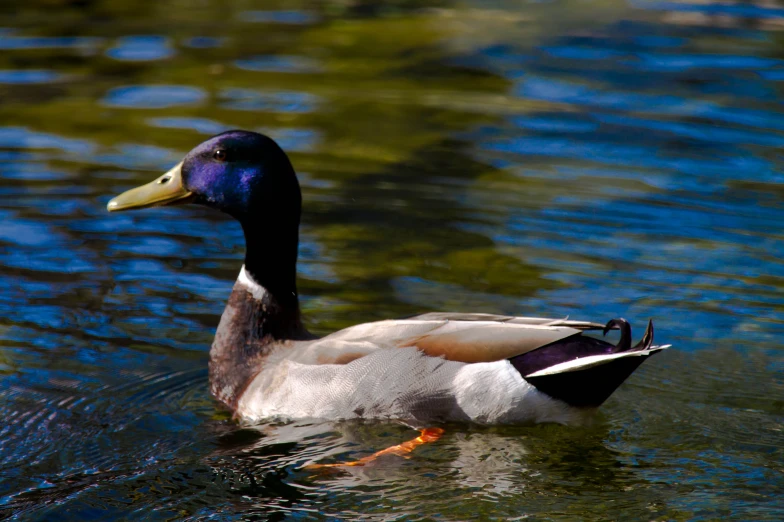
left=107, top=130, right=302, bottom=301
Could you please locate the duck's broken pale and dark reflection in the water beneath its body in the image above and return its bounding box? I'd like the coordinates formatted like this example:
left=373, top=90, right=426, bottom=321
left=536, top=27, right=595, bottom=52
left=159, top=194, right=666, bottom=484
left=204, top=421, right=640, bottom=516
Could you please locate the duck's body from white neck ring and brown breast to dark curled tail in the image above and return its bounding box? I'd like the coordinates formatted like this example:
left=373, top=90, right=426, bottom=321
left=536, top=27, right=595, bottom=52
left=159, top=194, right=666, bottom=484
left=210, top=267, right=661, bottom=426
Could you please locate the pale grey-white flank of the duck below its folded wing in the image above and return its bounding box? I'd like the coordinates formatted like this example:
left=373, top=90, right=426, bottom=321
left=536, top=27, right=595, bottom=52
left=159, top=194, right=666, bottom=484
left=236, top=348, right=592, bottom=426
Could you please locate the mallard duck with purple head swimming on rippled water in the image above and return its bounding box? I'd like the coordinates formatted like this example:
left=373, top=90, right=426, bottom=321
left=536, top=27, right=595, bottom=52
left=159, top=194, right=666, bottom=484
left=108, top=130, right=667, bottom=434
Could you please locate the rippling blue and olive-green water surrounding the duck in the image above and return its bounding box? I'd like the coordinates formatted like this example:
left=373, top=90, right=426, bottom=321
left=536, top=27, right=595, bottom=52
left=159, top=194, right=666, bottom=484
left=0, top=0, right=784, bottom=520
